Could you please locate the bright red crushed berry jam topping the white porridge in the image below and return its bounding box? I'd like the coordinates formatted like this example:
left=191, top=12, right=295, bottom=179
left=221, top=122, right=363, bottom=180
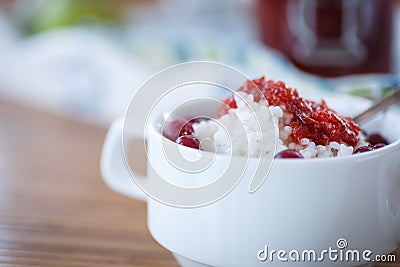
left=217, top=77, right=361, bottom=147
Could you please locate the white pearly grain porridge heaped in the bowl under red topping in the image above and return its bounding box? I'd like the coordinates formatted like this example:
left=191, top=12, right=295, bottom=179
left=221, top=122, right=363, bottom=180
left=193, top=92, right=368, bottom=159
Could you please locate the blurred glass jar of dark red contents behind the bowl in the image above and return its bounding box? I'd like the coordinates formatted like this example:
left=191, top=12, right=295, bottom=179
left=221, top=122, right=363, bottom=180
left=256, top=0, right=396, bottom=76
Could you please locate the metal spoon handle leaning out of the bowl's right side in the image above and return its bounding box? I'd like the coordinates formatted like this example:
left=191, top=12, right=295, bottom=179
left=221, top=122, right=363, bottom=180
left=353, top=87, right=400, bottom=124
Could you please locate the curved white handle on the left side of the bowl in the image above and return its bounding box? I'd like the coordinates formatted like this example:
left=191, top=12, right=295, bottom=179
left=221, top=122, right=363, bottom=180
left=100, top=118, right=147, bottom=201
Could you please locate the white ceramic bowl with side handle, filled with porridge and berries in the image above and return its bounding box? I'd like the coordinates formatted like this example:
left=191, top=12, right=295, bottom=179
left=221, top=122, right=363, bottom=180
left=101, top=94, right=400, bottom=266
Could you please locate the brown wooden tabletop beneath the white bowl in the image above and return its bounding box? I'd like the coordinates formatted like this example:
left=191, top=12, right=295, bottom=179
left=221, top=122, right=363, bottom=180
left=0, top=100, right=400, bottom=267
